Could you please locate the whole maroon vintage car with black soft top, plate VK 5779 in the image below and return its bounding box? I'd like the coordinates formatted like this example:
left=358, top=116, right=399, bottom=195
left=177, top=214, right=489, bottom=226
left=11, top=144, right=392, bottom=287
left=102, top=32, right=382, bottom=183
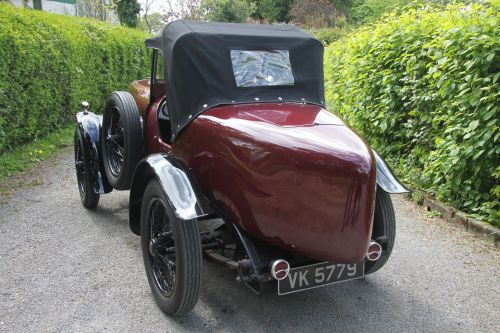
left=75, top=20, right=407, bottom=314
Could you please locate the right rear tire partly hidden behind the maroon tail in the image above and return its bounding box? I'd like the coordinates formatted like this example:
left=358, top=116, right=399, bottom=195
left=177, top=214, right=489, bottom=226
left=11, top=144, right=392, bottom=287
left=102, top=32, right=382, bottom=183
left=365, top=186, right=396, bottom=274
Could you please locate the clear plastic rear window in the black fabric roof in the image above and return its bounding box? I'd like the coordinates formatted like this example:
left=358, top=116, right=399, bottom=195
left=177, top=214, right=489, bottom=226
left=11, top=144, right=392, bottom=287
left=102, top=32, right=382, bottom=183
left=231, top=50, right=294, bottom=87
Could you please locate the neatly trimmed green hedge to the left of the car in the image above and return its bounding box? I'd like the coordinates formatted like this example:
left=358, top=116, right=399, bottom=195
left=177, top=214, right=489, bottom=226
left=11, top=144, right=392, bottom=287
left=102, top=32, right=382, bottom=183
left=0, top=3, right=149, bottom=153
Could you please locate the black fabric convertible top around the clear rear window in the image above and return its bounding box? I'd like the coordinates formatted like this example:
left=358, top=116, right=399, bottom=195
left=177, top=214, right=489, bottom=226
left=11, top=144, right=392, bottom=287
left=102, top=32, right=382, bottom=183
left=146, top=20, right=324, bottom=140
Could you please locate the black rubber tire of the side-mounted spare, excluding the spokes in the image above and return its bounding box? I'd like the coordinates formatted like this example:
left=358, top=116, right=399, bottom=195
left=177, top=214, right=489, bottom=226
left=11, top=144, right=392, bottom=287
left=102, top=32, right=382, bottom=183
left=101, top=91, right=144, bottom=190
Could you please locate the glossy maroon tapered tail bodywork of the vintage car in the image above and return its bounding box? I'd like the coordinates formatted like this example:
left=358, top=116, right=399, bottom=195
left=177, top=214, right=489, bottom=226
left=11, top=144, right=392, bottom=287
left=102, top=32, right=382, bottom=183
left=147, top=103, right=376, bottom=263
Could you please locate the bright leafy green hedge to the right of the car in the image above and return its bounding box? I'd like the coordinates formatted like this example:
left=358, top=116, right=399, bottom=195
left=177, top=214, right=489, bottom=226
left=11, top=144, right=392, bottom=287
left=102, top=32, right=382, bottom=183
left=325, top=0, right=500, bottom=226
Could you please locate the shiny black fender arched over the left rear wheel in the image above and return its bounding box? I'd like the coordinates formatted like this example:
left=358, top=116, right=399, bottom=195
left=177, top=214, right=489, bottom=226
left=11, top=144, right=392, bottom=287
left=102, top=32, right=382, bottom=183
left=129, top=154, right=212, bottom=235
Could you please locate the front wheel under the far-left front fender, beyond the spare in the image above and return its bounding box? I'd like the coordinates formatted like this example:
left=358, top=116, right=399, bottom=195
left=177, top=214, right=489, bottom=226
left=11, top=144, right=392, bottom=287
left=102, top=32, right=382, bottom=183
left=74, top=128, right=100, bottom=208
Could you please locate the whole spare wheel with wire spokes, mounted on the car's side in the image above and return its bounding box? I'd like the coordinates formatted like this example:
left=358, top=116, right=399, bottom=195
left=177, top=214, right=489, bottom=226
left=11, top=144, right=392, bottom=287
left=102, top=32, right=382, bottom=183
left=102, top=91, right=144, bottom=190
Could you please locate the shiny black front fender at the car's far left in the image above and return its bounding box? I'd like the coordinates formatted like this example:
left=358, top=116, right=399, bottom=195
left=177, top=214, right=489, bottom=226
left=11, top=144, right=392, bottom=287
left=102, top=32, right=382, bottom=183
left=76, top=111, right=113, bottom=194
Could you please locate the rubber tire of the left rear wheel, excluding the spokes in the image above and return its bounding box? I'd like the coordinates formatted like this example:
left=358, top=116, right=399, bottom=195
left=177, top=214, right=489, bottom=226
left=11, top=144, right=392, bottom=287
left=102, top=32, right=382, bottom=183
left=141, top=179, right=203, bottom=315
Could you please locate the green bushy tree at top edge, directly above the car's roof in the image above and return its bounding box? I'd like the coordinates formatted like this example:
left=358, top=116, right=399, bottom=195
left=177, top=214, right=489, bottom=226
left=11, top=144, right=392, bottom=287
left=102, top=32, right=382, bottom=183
left=200, top=0, right=254, bottom=22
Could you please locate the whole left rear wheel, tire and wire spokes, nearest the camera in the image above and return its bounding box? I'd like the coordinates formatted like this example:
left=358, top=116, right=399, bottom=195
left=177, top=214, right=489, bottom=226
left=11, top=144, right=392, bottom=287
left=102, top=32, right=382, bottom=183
left=141, top=179, right=202, bottom=315
